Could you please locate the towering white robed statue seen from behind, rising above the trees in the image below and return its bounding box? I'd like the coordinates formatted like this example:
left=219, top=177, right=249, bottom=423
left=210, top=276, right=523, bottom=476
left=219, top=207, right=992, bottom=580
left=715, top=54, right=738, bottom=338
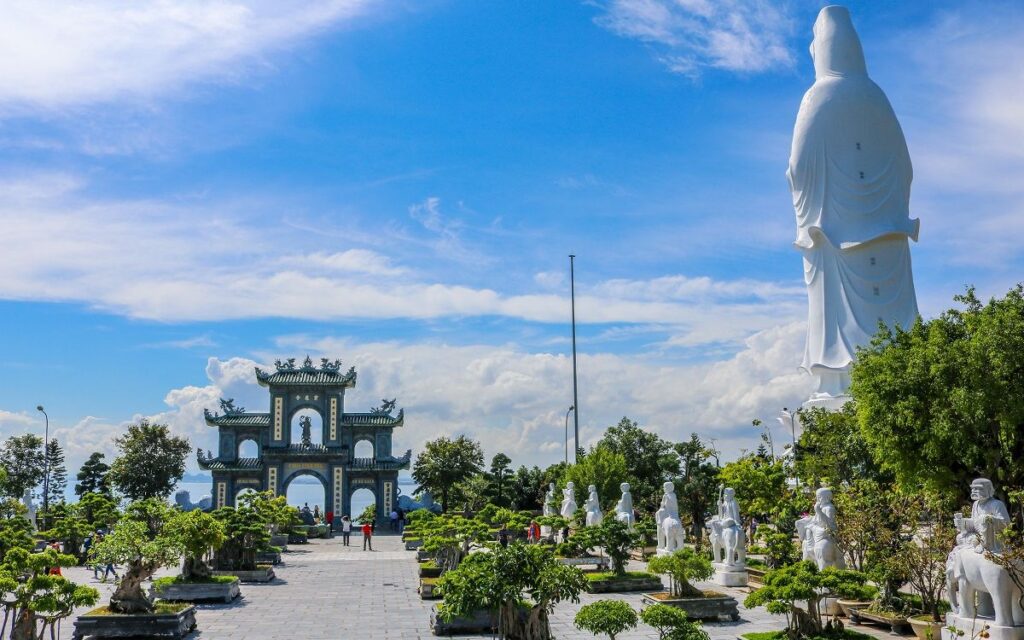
left=786, top=6, right=920, bottom=409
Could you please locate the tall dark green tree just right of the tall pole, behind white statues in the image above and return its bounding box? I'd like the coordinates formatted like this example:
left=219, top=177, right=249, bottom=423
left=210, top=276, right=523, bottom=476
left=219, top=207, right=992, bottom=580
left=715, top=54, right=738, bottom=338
left=598, top=418, right=679, bottom=513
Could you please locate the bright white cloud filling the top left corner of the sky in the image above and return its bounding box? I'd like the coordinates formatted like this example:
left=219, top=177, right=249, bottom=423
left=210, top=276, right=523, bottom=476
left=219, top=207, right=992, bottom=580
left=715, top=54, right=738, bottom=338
left=0, top=0, right=374, bottom=111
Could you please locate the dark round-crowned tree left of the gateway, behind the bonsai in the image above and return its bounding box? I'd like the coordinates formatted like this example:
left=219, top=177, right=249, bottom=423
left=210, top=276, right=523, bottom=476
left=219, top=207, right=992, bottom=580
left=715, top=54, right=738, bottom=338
left=108, top=419, right=191, bottom=501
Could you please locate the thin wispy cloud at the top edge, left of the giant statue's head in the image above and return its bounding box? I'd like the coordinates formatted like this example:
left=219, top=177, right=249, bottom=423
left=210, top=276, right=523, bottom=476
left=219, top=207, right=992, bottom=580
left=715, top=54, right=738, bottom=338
left=596, top=0, right=794, bottom=76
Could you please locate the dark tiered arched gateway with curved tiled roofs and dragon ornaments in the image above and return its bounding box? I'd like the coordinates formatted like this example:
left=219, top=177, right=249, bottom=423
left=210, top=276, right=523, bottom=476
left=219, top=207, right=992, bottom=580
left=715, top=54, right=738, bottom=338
left=197, top=356, right=413, bottom=526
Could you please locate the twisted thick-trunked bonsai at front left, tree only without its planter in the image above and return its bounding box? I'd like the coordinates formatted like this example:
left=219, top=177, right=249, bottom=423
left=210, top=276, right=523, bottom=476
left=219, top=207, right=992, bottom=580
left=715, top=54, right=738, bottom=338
left=90, top=499, right=181, bottom=613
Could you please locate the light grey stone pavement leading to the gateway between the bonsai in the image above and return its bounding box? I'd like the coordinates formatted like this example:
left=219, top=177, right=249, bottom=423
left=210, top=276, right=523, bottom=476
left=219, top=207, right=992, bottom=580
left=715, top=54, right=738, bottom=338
left=61, top=536, right=888, bottom=640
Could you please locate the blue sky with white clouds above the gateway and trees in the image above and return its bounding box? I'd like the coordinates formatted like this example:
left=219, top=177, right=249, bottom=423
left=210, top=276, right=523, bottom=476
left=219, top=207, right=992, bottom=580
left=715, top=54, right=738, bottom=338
left=0, top=0, right=1024, bottom=489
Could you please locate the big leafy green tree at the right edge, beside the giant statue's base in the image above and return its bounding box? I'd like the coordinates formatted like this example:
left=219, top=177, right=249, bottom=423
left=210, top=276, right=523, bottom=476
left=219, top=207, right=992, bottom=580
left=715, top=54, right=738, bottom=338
left=850, top=285, right=1024, bottom=493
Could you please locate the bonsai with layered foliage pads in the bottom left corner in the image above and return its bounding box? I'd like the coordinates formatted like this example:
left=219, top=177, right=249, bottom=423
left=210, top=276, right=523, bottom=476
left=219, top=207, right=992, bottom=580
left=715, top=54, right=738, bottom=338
left=0, top=548, right=99, bottom=640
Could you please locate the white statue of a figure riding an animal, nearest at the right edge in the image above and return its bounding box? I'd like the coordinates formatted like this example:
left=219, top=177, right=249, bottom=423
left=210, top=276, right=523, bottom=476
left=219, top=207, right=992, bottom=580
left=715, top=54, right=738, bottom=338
left=942, top=478, right=1024, bottom=640
